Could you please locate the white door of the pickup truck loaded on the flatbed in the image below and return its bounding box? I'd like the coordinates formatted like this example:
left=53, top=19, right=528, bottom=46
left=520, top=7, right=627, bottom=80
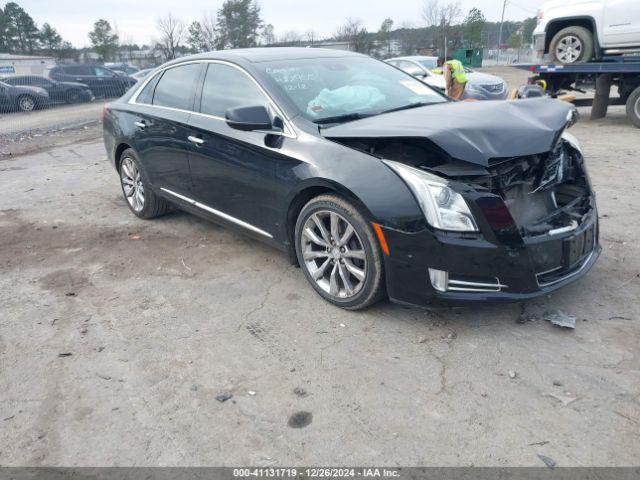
left=603, top=0, right=640, bottom=47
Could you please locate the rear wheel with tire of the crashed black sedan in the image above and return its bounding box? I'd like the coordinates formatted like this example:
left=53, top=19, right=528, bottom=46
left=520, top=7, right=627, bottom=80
left=118, top=148, right=171, bottom=220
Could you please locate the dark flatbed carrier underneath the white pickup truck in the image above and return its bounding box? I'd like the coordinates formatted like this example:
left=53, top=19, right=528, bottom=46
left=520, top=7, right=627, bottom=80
left=526, top=57, right=640, bottom=128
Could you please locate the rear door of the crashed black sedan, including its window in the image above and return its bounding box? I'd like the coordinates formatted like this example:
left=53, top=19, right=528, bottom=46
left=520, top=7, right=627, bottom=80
left=130, top=63, right=202, bottom=195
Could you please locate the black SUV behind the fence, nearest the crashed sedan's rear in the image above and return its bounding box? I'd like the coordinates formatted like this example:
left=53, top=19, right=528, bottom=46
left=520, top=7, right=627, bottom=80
left=47, top=65, right=136, bottom=97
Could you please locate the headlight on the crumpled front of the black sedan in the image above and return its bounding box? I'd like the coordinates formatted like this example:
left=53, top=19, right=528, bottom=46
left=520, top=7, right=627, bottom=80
left=385, top=160, right=478, bottom=232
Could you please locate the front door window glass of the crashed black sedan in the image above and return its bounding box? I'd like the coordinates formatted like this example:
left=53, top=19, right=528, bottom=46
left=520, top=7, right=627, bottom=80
left=200, top=63, right=269, bottom=118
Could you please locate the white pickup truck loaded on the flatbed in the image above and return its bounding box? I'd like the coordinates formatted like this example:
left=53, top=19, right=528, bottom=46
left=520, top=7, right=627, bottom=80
left=533, top=0, right=640, bottom=64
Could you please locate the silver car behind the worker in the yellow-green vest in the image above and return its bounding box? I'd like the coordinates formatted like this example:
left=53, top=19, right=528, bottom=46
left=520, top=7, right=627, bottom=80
left=387, top=55, right=509, bottom=100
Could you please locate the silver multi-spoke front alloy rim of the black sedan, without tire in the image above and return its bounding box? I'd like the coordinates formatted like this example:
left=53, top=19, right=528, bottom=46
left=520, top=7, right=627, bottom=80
left=300, top=210, right=367, bottom=299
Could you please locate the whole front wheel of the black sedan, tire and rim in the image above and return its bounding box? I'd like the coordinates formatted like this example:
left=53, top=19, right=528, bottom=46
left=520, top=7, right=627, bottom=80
left=295, top=195, right=384, bottom=310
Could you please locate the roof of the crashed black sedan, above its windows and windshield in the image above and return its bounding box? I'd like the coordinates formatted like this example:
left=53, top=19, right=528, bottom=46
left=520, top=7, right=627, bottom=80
left=165, top=47, right=363, bottom=63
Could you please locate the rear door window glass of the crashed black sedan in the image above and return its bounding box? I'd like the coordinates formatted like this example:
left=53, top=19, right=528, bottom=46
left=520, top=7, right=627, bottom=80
left=153, top=63, right=200, bottom=110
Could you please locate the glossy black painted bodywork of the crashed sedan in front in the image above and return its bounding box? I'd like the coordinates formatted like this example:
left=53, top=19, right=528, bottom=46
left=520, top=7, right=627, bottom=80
left=104, top=49, right=600, bottom=305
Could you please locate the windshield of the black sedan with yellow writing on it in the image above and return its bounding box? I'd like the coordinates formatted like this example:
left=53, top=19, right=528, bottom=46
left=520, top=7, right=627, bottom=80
left=259, top=57, right=447, bottom=123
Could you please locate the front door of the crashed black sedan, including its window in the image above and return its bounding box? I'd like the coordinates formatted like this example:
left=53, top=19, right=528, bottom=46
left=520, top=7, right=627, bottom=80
left=190, top=63, right=288, bottom=236
